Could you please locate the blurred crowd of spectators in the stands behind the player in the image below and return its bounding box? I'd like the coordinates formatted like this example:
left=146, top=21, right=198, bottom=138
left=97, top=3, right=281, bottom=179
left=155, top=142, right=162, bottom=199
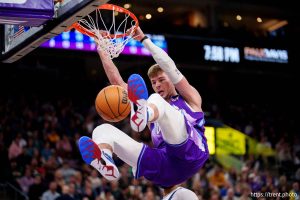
left=0, top=96, right=300, bottom=200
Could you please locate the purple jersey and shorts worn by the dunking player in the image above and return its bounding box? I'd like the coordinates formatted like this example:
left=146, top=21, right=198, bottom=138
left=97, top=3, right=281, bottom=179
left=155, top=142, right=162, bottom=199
left=136, top=95, right=209, bottom=187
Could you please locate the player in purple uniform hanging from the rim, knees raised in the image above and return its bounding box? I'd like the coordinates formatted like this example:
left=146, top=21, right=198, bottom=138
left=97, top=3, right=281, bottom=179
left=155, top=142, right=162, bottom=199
left=79, top=28, right=209, bottom=189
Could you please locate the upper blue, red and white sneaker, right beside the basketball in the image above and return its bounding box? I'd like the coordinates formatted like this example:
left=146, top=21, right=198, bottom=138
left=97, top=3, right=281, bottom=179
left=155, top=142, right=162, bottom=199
left=127, top=74, right=148, bottom=132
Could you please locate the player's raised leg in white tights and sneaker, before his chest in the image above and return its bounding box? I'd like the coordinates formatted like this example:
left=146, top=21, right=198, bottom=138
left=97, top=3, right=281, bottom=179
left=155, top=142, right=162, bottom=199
left=128, top=74, right=188, bottom=144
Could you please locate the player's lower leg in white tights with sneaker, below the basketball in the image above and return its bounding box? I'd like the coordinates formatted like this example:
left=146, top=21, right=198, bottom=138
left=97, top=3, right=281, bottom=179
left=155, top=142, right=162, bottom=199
left=79, top=124, right=143, bottom=180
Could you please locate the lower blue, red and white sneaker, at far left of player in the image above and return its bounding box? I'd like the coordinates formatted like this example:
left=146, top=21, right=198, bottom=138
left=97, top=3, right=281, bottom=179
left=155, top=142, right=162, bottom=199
left=78, top=136, right=120, bottom=181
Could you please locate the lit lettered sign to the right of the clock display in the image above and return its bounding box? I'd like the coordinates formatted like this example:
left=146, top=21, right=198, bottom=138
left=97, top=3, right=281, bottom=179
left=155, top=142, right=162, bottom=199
left=244, top=47, right=289, bottom=63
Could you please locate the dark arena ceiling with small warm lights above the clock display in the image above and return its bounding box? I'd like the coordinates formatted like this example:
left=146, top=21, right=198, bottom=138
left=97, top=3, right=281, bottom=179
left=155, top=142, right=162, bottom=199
left=110, top=0, right=300, bottom=36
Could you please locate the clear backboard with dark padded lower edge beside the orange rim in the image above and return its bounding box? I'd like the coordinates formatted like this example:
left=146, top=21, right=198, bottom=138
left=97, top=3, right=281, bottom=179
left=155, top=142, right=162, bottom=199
left=0, top=0, right=109, bottom=63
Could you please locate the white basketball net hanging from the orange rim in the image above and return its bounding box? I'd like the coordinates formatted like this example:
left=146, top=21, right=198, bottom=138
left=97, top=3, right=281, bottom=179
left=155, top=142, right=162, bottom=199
left=78, top=6, right=136, bottom=59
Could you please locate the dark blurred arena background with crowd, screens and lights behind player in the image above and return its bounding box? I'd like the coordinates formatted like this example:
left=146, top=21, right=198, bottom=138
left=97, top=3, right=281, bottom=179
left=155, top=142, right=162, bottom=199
left=0, top=0, right=300, bottom=200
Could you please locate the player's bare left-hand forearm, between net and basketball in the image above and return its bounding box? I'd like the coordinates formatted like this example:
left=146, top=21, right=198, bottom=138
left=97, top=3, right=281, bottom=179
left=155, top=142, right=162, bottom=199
left=97, top=48, right=127, bottom=90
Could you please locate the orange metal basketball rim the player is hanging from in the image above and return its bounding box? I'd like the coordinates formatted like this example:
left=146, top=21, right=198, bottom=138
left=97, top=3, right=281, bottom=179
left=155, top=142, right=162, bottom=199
left=70, top=4, right=139, bottom=38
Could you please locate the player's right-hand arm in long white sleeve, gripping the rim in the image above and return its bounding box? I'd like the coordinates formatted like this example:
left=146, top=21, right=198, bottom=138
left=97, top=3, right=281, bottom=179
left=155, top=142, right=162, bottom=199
left=134, top=28, right=202, bottom=111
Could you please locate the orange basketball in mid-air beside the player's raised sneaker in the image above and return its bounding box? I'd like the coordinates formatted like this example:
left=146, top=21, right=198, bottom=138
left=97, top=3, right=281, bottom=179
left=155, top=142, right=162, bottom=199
left=95, top=85, right=130, bottom=122
